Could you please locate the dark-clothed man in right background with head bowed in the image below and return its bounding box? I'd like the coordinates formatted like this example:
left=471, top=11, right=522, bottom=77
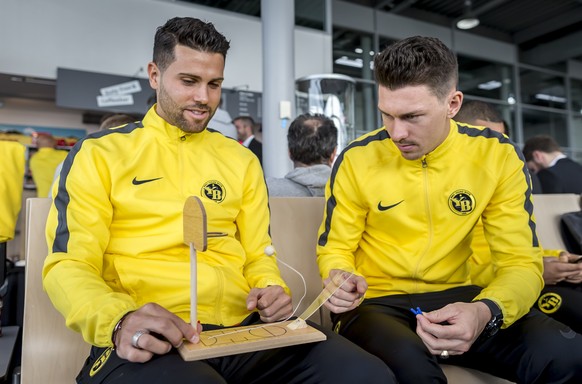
left=523, top=135, right=582, bottom=194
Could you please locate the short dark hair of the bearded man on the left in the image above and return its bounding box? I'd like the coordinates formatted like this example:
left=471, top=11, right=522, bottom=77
left=153, top=17, right=230, bottom=71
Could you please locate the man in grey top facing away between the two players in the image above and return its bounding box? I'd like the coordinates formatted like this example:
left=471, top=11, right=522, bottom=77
left=267, top=113, right=337, bottom=197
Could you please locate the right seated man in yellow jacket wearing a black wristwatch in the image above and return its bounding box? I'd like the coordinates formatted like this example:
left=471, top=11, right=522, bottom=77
left=317, top=36, right=582, bottom=384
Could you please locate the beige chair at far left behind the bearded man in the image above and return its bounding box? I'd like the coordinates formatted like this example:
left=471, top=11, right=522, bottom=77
left=21, top=198, right=90, bottom=384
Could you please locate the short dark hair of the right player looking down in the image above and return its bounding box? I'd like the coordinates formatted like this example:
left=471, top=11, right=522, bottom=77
left=374, top=36, right=458, bottom=98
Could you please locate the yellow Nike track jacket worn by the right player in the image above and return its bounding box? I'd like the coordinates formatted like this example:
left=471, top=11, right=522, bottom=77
left=317, top=120, right=543, bottom=327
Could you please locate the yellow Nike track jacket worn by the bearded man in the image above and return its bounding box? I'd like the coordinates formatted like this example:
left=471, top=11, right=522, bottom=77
left=43, top=106, right=287, bottom=347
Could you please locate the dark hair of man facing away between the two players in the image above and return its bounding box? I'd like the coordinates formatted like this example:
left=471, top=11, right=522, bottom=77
left=287, top=113, right=337, bottom=165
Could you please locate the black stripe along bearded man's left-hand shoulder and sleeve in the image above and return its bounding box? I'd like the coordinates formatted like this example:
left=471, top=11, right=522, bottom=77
left=52, top=122, right=143, bottom=253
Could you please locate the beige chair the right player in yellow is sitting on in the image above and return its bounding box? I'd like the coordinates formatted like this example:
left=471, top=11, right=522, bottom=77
left=269, top=197, right=510, bottom=384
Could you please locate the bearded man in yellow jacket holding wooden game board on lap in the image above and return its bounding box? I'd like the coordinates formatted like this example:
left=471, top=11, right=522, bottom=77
left=43, top=18, right=394, bottom=384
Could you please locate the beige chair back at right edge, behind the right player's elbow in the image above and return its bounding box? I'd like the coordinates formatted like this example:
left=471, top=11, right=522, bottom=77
left=533, top=193, right=580, bottom=250
